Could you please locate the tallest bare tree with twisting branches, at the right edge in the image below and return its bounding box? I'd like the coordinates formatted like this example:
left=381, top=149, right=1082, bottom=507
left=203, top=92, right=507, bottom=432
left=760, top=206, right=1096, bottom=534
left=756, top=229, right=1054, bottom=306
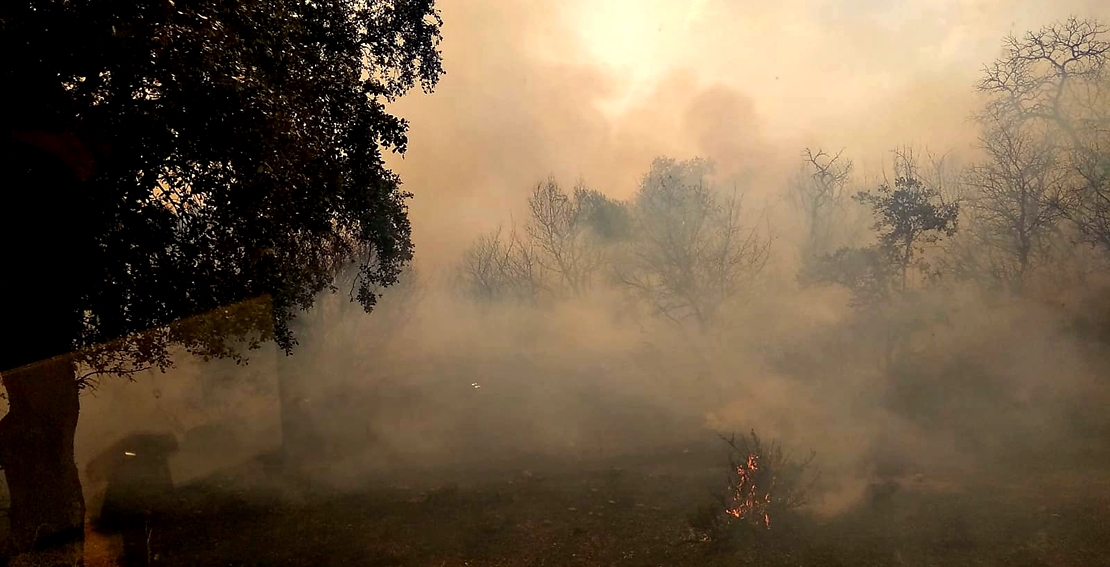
left=978, top=18, right=1110, bottom=251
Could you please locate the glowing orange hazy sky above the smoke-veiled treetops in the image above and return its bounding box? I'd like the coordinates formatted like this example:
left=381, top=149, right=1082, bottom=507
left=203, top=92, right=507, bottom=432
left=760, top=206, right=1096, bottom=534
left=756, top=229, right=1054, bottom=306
left=384, top=0, right=1110, bottom=269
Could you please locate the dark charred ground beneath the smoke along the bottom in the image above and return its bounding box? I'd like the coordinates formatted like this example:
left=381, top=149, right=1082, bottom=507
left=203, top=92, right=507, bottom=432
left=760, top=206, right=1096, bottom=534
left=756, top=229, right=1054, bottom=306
left=76, top=450, right=1110, bottom=567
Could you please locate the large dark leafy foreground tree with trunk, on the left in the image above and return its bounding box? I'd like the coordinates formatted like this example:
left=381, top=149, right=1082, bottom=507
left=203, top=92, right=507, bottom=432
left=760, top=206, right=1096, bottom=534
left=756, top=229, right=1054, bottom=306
left=0, top=0, right=442, bottom=549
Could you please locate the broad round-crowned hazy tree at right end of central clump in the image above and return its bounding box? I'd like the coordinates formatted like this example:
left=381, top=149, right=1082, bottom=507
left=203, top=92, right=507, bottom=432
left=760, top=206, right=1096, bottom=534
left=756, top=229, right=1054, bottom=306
left=617, top=158, right=770, bottom=330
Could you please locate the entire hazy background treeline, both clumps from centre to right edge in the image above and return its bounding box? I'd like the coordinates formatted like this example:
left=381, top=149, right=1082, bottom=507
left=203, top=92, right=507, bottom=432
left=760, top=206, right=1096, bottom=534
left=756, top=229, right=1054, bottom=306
left=458, top=18, right=1110, bottom=332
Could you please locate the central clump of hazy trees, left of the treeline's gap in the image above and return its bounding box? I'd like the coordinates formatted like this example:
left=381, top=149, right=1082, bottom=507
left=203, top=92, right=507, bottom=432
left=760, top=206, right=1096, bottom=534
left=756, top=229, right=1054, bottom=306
left=458, top=158, right=770, bottom=327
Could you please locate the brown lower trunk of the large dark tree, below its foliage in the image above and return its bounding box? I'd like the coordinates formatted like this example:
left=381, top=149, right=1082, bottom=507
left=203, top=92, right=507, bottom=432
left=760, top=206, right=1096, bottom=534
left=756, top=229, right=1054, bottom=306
left=0, top=355, right=84, bottom=553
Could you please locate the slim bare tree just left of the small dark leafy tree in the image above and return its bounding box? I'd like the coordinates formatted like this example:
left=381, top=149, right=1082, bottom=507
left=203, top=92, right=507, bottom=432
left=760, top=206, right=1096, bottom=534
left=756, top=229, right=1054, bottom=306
left=791, top=148, right=852, bottom=257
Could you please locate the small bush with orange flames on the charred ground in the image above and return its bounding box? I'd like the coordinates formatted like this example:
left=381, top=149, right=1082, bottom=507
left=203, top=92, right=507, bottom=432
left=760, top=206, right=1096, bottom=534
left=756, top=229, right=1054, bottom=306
left=690, top=431, right=819, bottom=541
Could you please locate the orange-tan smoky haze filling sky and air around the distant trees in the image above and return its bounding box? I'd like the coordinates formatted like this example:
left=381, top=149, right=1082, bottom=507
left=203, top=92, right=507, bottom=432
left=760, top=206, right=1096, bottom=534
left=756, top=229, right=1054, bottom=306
left=78, top=0, right=1110, bottom=525
